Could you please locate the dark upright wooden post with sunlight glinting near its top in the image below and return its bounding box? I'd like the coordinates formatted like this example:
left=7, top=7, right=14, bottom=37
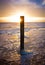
left=20, top=16, right=24, bottom=52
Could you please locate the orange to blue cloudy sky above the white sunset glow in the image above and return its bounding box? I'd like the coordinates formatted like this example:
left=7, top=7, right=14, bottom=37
left=0, top=0, right=45, bottom=22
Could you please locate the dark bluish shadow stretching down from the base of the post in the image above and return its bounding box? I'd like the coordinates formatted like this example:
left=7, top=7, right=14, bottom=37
left=20, top=54, right=32, bottom=65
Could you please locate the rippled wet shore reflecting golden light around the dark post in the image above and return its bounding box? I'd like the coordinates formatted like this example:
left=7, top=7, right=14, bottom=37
left=0, top=23, right=45, bottom=65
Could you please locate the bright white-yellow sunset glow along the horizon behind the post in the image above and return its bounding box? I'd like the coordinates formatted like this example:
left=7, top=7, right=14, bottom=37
left=1, top=12, right=43, bottom=22
